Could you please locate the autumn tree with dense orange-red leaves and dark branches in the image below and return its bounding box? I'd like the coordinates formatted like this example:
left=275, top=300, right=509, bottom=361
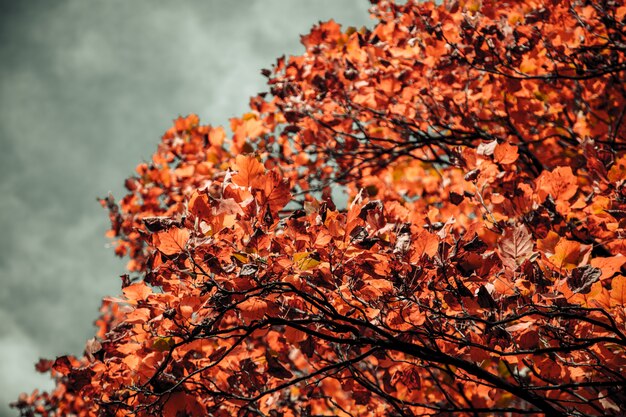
left=15, top=0, right=626, bottom=417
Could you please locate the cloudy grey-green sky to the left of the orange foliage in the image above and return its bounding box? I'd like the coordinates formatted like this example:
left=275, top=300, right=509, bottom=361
left=0, top=0, right=371, bottom=417
